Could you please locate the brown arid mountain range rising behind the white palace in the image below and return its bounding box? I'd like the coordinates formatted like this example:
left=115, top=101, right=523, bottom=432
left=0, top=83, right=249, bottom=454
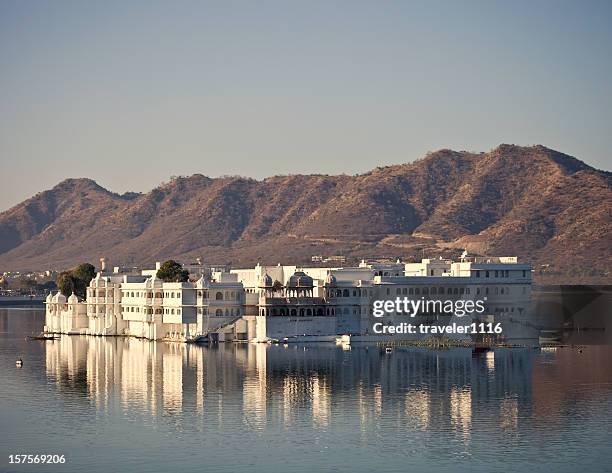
left=0, top=145, right=612, bottom=282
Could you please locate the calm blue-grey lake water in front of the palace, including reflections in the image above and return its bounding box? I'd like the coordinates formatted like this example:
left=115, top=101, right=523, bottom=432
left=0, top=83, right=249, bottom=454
left=0, top=308, right=612, bottom=473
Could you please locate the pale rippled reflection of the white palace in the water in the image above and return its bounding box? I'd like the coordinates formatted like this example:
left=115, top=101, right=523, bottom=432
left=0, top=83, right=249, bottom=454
left=45, top=336, right=532, bottom=436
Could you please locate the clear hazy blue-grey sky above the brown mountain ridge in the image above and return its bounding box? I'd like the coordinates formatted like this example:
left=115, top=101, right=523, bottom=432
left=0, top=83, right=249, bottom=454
left=0, top=0, right=612, bottom=210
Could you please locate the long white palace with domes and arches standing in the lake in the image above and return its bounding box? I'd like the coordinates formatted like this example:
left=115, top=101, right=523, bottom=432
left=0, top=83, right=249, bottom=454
left=45, top=253, right=532, bottom=342
